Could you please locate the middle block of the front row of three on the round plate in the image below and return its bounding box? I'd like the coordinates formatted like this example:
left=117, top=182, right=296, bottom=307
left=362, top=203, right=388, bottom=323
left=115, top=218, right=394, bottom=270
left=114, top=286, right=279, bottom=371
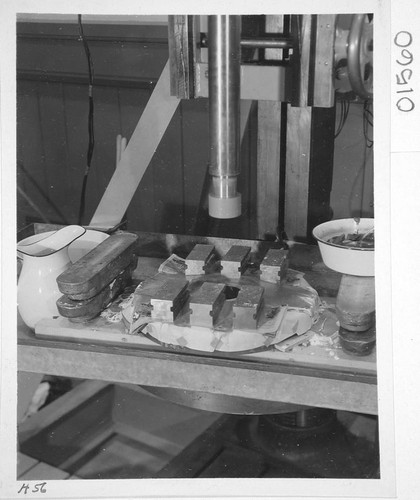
left=190, top=282, right=226, bottom=328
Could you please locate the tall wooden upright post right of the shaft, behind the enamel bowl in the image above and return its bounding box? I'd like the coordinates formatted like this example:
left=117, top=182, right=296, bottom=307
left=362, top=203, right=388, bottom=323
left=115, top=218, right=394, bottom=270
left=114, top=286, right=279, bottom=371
left=284, top=15, right=335, bottom=241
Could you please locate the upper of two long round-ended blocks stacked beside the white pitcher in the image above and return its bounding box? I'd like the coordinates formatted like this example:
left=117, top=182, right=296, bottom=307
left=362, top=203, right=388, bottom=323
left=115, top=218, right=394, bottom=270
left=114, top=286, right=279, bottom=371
left=57, top=232, right=138, bottom=300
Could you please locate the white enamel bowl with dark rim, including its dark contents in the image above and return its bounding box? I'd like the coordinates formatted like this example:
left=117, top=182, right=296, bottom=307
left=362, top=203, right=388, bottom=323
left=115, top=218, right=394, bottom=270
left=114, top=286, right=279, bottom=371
left=312, top=218, right=375, bottom=276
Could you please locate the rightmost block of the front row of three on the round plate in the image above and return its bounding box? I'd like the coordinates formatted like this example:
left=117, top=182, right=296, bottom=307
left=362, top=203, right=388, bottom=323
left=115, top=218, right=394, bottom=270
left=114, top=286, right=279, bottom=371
left=233, top=285, right=264, bottom=330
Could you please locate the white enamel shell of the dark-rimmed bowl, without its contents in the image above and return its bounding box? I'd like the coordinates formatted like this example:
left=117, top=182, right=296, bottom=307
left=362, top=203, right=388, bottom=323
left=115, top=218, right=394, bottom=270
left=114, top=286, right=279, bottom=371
left=312, top=218, right=375, bottom=276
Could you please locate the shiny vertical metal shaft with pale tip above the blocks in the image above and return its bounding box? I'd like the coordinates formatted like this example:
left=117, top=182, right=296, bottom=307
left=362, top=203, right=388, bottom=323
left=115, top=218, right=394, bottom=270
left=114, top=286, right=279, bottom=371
left=209, top=16, right=241, bottom=219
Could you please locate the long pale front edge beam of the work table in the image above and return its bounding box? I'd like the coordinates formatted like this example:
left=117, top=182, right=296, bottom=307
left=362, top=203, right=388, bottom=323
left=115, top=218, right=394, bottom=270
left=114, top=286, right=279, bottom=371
left=18, top=329, right=378, bottom=415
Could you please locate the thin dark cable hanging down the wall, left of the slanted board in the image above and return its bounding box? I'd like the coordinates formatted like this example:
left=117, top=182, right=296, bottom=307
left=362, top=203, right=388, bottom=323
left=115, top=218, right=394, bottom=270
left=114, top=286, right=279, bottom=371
left=77, top=14, right=95, bottom=225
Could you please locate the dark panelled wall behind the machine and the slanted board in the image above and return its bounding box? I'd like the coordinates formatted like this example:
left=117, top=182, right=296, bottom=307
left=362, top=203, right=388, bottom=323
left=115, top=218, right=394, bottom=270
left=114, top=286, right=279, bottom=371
left=17, top=17, right=373, bottom=238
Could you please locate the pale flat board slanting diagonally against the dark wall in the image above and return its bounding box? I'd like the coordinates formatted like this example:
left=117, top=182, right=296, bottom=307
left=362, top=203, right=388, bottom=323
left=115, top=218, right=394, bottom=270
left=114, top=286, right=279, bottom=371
left=89, top=62, right=180, bottom=229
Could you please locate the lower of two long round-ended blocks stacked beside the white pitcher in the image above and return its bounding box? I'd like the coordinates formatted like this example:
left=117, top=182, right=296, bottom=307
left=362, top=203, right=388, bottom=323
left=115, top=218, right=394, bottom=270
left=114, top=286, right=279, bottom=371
left=57, top=265, right=133, bottom=321
